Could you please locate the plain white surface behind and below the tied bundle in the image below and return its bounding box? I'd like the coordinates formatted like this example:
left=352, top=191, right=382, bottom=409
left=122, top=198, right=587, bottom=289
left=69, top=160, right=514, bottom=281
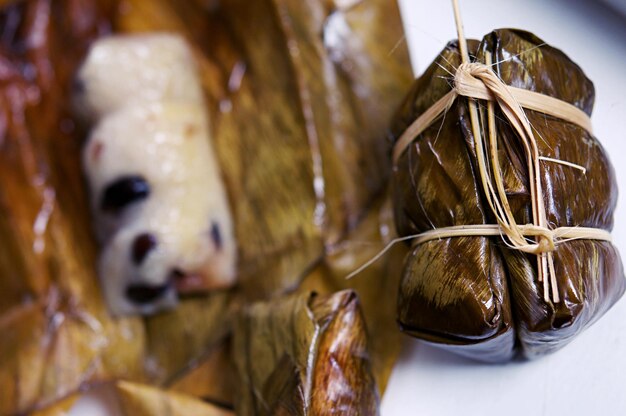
left=382, top=0, right=626, bottom=416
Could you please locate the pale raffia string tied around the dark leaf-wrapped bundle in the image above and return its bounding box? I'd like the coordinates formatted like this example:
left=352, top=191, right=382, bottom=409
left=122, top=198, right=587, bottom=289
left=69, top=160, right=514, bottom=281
left=386, top=0, right=611, bottom=303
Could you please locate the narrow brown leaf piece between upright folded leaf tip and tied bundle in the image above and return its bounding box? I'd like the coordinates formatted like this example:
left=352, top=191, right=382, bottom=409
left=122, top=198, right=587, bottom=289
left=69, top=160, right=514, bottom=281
left=299, top=193, right=407, bottom=396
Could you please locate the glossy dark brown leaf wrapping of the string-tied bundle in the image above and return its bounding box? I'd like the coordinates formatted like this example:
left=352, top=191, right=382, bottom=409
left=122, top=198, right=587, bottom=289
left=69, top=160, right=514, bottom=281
left=392, top=29, right=624, bottom=361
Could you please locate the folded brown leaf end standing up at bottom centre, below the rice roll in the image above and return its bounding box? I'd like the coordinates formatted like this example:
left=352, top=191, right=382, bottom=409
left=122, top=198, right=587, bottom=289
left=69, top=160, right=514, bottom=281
left=233, top=290, right=379, bottom=415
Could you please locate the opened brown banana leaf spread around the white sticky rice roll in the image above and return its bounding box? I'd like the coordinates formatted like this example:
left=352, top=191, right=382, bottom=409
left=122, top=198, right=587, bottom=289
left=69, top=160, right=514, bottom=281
left=0, top=0, right=411, bottom=415
